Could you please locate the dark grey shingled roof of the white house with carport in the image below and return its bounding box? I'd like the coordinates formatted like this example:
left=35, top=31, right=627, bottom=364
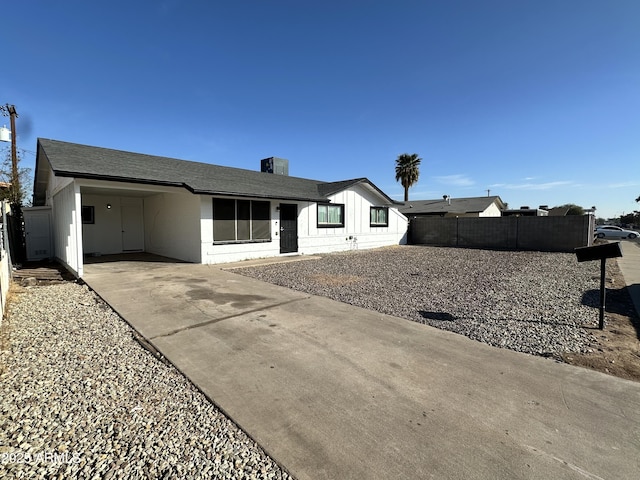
left=34, top=138, right=396, bottom=205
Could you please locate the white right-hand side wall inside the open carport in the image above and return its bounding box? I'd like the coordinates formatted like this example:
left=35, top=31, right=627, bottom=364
left=144, top=191, right=202, bottom=263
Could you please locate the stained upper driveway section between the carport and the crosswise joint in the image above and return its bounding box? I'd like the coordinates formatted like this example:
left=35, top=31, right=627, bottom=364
left=84, top=262, right=304, bottom=338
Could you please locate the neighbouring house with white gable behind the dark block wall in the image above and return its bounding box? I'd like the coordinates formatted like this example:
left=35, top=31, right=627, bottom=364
left=400, top=195, right=505, bottom=218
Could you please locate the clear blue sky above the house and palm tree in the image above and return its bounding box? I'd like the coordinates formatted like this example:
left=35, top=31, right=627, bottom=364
left=0, top=0, right=640, bottom=217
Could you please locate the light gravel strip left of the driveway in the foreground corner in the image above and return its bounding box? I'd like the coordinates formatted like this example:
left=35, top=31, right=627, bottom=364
left=0, top=282, right=290, bottom=479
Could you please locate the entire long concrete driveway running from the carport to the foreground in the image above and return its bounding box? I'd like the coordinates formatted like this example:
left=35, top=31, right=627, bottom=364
left=85, top=253, right=640, bottom=480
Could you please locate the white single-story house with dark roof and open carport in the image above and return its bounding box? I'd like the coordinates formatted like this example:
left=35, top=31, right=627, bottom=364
left=33, top=139, right=407, bottom=277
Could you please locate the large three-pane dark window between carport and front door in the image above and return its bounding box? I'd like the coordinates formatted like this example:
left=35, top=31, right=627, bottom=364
left=213, top=198, right=271, bottom=242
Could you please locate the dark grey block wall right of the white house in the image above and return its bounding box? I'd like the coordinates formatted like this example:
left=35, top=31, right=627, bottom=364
left=409, top=215, right=595, bottom=252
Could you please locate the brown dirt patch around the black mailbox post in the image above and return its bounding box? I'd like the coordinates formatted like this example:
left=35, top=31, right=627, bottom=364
left=563, top=261, right=640, bottom=382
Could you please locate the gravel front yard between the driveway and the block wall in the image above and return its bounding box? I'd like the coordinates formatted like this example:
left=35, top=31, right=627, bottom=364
left=235, top=246, right=600, bottom=359
